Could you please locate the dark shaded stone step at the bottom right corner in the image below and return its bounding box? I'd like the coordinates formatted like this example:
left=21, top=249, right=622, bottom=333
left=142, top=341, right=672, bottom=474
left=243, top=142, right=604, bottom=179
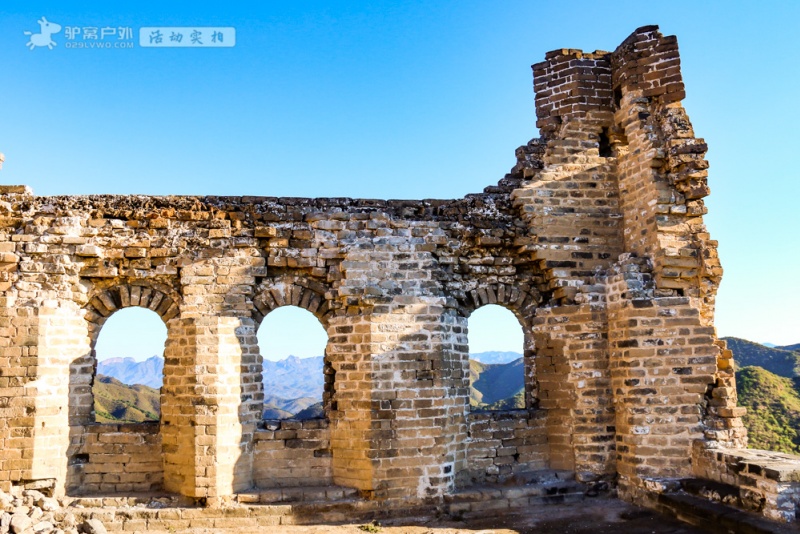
left=657, top=491, right=798, bottom=534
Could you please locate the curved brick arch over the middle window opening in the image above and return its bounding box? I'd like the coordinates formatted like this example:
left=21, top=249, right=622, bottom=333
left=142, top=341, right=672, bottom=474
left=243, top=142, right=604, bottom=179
left=253, top=277, right=333, bottom=330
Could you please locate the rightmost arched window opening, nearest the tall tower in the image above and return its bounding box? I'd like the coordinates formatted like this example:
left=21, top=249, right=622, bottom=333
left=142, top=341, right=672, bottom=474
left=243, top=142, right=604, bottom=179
left=468, top=304, right=525, bottom=411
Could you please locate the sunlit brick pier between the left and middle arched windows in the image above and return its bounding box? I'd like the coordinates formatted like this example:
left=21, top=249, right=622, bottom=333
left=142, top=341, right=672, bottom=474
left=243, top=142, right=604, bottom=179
left=162, top=317, right=260, bottom=498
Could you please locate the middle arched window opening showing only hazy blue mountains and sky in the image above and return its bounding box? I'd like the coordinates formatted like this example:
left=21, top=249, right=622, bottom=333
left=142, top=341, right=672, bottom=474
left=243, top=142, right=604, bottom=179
left=258, top=306, right=328, bottom=419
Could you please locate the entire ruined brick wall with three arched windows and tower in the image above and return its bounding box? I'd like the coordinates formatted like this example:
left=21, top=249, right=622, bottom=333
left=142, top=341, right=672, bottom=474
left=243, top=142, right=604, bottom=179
left=0, top=26, right=800, bottom=531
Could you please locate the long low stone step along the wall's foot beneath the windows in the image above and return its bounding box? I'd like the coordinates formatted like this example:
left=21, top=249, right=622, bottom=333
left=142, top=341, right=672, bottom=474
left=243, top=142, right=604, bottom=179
left=64, top=480, right=600, bottom=531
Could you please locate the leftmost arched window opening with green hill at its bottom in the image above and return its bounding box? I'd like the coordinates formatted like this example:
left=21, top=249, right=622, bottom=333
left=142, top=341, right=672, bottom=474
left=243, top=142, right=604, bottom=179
left=92, top=307, right=167, bottom=423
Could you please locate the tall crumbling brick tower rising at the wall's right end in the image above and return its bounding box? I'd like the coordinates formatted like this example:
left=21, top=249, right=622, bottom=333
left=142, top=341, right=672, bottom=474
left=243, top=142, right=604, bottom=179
left=512, top=26, right=746, bottom=494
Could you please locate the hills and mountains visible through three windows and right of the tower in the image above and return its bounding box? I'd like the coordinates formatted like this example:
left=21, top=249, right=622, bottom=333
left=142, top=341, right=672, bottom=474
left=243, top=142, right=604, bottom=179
left=94, top=337, right=800, bottom=453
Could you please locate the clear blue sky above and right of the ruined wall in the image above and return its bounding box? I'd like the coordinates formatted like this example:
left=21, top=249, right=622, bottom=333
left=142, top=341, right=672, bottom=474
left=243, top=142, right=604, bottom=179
left=0, top=1, right=800, bottom=360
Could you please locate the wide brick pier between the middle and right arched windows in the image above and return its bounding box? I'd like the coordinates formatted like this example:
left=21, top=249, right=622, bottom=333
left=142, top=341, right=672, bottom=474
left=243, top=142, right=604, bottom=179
left=329, top=297, right=469, bottom=499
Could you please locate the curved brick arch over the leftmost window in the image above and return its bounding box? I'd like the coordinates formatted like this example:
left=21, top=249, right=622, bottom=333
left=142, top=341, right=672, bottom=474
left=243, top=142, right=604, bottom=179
left=84, top=282, right=180, bottom=347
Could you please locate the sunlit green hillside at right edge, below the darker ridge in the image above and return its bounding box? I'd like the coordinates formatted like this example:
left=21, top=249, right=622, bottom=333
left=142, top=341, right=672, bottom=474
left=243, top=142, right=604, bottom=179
left=734, top=368, right=800, bottom=454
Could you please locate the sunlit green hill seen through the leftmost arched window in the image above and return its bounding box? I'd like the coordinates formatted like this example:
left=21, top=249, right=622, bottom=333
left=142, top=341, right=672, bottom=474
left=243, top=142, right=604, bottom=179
left=92, top=375, right=161, bottom=423
